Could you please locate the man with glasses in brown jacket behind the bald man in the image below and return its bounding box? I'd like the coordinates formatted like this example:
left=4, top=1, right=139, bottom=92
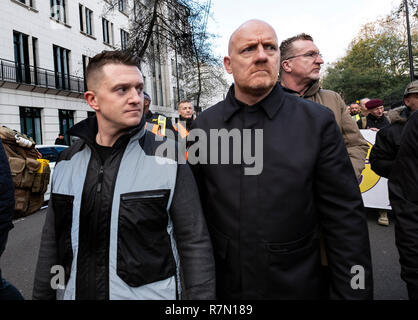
left=280, top=33, right=369, bottom=178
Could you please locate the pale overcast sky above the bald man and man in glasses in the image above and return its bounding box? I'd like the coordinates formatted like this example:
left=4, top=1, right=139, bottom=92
left=208, top=0, right=402, bottom=63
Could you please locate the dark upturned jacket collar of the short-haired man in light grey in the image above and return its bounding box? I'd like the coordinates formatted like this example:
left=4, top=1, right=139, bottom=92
left=67, top=116, right=145, bottom=149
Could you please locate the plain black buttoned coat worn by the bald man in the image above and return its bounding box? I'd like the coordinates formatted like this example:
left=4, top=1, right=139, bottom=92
left=189, top=84, right=373, bottom=299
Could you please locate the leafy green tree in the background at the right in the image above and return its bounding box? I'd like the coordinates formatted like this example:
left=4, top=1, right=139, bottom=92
left=322, top=1, right=418, bottom=106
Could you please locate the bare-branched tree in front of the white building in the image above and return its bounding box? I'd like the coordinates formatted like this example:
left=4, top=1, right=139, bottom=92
left=103, top=0, right=222, bottom=110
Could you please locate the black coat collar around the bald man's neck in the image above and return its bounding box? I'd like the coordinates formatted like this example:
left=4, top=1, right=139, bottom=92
left=223, top=83, right=284, bottom=122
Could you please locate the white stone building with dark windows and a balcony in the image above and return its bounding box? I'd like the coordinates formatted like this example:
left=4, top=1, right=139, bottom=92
left=0, top=0, right=183, bottom=144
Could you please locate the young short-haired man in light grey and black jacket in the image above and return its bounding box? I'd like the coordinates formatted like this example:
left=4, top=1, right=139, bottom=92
left=33, top=51, right=215, bottom=300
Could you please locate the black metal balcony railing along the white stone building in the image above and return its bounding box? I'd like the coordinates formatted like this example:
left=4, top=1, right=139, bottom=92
left=0, top=59, right=85, bottom=94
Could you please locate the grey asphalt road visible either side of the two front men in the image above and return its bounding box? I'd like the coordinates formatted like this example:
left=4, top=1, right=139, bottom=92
left=0, top=209, right=408, bottom=300
